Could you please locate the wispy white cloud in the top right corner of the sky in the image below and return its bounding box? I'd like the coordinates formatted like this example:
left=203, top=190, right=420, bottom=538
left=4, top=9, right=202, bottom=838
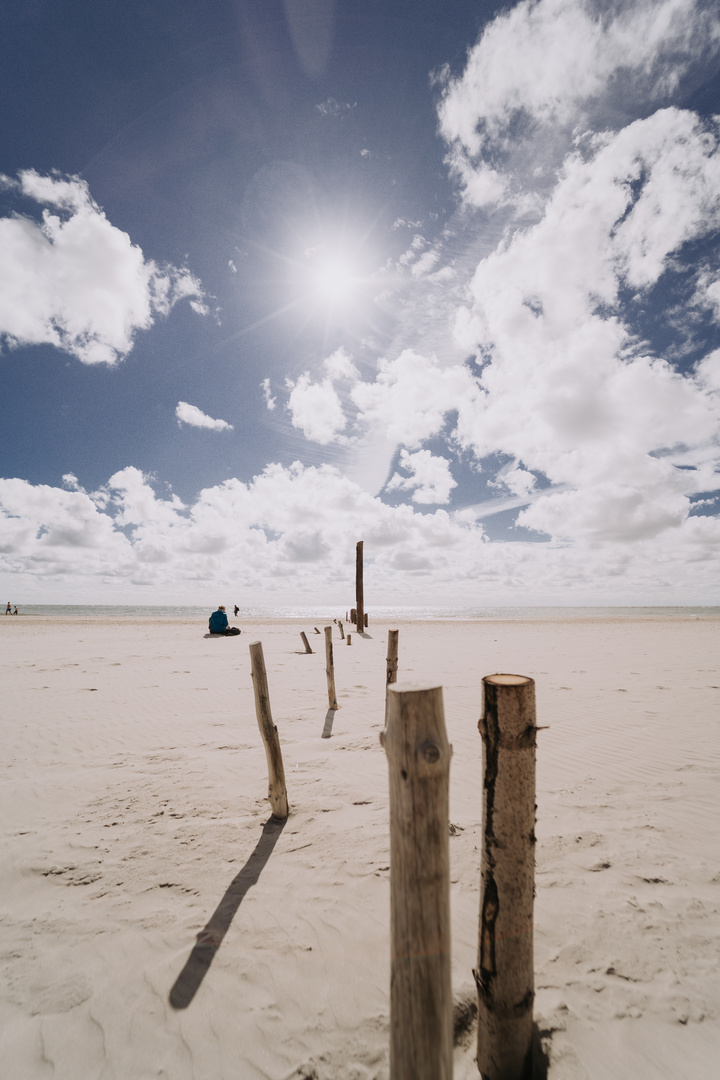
left=438, top=0, right=720, bottom=206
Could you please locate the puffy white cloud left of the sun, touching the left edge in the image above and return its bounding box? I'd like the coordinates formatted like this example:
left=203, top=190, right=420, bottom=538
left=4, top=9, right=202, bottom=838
left=0, top=170, right=207, bottom=364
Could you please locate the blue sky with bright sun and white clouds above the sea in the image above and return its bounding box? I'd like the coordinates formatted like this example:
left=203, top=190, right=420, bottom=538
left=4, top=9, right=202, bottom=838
left=0, top=0, right=720, bottom=611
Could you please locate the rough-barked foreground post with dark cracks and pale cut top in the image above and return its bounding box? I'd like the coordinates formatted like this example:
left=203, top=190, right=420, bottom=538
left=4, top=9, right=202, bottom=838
left=474, top=675, right=536, bottom=1080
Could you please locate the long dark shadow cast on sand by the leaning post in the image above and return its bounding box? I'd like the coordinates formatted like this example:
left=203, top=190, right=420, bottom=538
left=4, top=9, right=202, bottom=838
left=169, top=818, right=287, bottom=1009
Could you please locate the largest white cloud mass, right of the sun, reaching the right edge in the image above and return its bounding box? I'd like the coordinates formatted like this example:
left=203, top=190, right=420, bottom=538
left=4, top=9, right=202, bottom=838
left=444, top=109, right=720, bottom=541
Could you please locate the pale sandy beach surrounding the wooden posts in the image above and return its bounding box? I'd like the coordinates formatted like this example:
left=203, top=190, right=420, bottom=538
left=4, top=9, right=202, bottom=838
left=0, top=612, right=720, bottom=1080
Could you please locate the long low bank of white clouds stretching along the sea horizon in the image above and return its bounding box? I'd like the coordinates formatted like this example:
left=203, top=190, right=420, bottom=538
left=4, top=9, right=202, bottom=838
left=0, top=462, right=720, bottom=605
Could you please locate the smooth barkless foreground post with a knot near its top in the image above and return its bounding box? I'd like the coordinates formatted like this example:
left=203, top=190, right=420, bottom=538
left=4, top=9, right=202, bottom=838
left=380, top=684, right=452, bottom=1080
